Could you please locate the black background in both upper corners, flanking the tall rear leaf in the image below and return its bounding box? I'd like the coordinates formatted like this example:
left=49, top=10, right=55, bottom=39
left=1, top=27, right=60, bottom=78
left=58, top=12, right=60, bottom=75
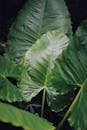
left=0, top=0, right=87, bottom=41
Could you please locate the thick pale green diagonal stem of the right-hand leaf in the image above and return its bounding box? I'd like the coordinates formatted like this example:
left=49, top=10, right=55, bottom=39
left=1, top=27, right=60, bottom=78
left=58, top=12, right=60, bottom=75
left=56, top=87, right=83, bottom=130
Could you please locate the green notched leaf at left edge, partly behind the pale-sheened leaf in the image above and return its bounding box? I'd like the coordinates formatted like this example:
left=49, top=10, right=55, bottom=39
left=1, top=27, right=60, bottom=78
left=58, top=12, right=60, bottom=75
left=0, top=56, right=22, bottom=102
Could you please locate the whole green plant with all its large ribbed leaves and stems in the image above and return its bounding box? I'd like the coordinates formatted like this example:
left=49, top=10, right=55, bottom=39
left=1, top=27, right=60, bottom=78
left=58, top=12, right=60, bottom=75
left=0, top=0, right=87, bottom=130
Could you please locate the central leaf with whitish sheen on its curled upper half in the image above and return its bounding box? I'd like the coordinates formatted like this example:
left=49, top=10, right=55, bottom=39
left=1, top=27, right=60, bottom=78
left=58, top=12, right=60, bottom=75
left=18, top=31, right=75, bottom=111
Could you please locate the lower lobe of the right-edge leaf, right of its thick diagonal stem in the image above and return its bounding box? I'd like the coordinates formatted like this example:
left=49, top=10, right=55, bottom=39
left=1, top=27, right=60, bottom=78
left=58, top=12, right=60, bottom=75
left=68, top=79, right=87, bottom=130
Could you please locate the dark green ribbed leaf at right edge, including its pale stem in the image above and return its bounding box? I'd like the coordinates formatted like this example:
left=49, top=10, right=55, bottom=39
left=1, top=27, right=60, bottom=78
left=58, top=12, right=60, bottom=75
left=54, top=21, right=87, bottom=130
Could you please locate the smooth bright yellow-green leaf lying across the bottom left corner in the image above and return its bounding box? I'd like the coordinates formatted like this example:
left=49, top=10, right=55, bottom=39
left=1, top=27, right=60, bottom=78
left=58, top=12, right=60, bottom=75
left=0, top=103, right=54, bottom=130
